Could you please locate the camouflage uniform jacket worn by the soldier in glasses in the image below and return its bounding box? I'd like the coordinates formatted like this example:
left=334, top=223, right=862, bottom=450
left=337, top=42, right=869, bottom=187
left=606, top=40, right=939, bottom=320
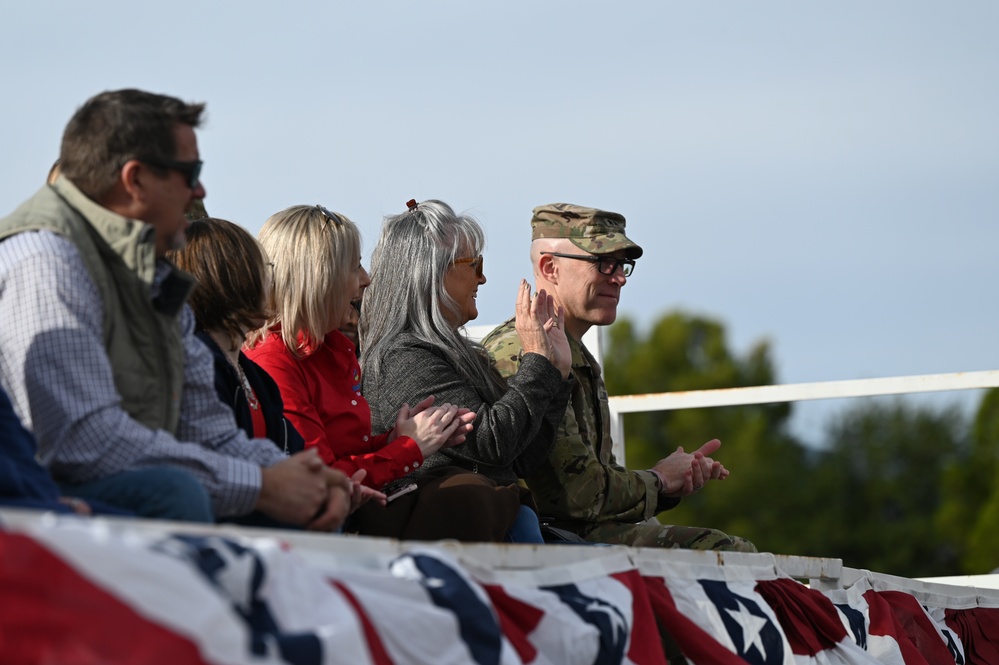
left=483, top=319, right=678, bottom=537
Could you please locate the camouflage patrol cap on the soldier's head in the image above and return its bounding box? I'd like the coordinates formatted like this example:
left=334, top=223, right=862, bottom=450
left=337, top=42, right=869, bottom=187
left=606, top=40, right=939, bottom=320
left=531, top=203, right=642, bottom=259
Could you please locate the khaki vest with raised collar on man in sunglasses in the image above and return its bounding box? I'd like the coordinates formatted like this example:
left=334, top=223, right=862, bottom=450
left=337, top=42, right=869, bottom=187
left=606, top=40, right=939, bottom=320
left=0, top=178, right=194, bottom=434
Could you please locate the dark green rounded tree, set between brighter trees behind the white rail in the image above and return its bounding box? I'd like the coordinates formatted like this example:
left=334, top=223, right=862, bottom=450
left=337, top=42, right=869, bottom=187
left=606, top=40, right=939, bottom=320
left=802, top=399, right=968, bottom=577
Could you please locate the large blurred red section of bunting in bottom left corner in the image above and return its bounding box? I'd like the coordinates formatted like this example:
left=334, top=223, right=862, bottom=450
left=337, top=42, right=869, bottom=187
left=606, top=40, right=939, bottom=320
left=0, top=532, right=207, bottom=665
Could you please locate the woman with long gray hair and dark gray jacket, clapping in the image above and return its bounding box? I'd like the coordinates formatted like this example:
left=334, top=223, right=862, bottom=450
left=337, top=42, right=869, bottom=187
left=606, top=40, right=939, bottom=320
left=360, top=200, right=572, bottom=540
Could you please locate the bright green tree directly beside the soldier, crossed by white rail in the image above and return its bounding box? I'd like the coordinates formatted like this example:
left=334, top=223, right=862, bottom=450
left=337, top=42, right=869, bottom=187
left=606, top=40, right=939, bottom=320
left=604, top=312, right=812, bottom=554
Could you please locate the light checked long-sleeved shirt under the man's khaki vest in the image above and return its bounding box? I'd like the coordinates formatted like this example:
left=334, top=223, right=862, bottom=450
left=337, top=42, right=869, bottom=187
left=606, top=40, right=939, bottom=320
left=0, top=231, right=284, bottom=517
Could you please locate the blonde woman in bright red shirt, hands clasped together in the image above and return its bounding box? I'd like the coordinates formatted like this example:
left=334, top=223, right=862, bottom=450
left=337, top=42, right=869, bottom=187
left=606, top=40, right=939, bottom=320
left=246, top=205, right=474, bottom=489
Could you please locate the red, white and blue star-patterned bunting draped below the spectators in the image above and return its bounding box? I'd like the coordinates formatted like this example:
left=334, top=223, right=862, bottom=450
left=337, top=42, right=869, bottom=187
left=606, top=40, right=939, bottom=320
left=0, top=517, right=999, bottom=665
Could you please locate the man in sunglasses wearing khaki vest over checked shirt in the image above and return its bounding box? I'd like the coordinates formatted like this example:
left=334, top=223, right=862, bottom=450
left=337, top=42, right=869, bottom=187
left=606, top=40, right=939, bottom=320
left=0, top=90, right=351, bottom=530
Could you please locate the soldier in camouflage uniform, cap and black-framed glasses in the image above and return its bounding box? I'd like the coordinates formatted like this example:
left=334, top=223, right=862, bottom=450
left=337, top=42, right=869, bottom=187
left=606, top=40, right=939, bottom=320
left=483, top=203, right=756, bottom=552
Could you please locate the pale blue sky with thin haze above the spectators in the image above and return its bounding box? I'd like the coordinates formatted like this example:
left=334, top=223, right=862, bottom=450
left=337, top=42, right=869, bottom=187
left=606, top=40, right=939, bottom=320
left=0, top=0, right=999, bottom=440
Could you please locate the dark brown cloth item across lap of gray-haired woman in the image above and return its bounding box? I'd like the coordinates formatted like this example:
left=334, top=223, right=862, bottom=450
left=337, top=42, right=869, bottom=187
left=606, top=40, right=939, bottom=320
left=347, top=466, right=533, bottom=542
